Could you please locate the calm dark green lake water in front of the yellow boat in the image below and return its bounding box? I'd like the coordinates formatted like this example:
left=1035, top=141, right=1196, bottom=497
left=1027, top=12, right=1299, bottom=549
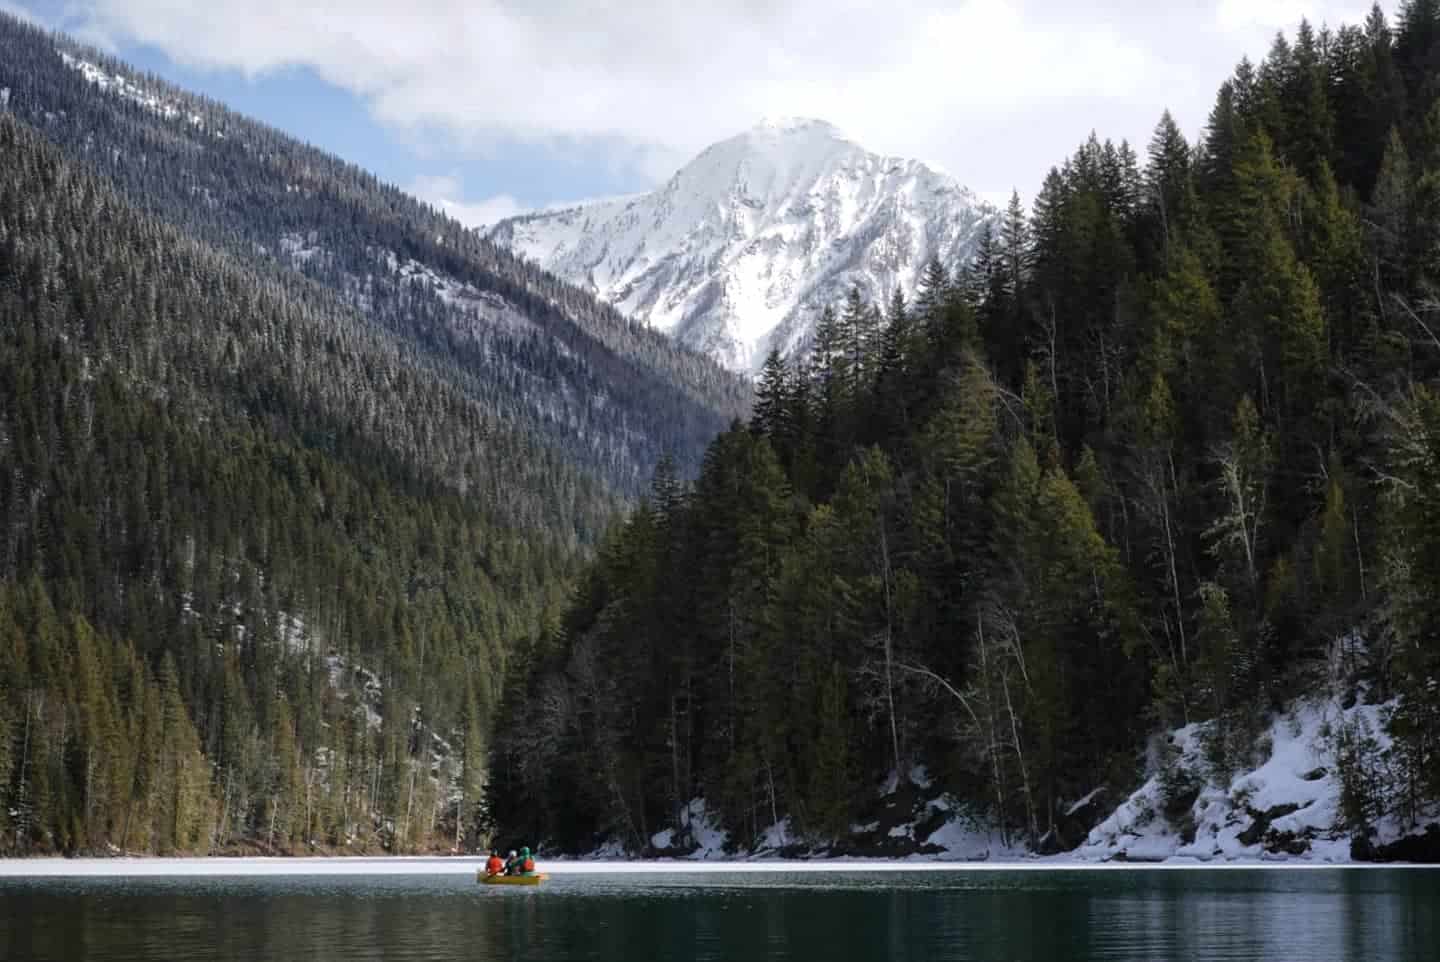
left=0, top=870, right=1440, bottom=962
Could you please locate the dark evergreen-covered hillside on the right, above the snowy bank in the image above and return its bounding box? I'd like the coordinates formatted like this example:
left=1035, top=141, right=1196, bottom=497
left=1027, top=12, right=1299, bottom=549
left=492, top=0, right=1440, bottom=851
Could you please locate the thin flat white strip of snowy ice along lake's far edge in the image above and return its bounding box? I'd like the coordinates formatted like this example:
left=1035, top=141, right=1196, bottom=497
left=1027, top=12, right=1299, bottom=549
left=0, top=855, right=1440, bottom=878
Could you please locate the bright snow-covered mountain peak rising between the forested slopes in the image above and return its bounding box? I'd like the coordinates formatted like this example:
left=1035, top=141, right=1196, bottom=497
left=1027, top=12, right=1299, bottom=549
left=490, top=120, right=994, bottom=372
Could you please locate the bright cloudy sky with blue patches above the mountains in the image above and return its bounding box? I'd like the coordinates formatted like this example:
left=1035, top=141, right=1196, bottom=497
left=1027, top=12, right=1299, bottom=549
left=8, top=0, right=1370, bottom=225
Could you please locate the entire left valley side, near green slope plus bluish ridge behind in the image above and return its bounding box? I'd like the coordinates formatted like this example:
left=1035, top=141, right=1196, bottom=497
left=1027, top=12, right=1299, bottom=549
left=0, top=14, right=749, bottom=854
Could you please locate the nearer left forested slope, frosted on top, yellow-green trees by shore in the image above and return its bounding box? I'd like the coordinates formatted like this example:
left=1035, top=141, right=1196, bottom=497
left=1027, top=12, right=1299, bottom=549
left=0, top=107, right=601, bottom=853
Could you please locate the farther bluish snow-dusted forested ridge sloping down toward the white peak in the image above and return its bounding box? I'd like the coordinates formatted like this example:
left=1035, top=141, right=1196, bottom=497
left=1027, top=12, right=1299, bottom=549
left=0, top=14, right=749, bottom=495
